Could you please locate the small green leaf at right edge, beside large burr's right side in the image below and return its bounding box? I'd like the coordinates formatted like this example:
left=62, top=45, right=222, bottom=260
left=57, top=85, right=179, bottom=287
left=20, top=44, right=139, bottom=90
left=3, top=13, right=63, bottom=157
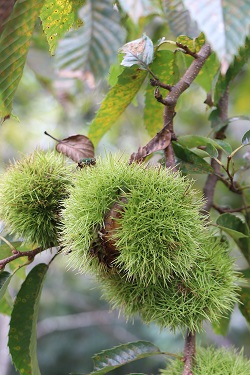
left=216, top=213, right=249, bottom=241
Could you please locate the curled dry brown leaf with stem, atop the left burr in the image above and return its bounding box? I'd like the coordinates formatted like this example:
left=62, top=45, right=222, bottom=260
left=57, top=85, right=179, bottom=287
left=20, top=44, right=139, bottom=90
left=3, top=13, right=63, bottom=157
left=44, top=132, right=95, bottom=163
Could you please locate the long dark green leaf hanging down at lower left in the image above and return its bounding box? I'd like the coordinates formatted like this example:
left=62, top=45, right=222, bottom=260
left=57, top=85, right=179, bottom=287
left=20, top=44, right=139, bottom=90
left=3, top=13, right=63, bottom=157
left=8, top=264, right=48, bottom=375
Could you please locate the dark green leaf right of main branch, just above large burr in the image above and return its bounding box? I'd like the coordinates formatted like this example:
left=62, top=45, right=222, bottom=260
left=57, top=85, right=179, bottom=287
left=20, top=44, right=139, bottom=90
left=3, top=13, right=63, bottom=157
left=172, top=142, right=213, bottom=174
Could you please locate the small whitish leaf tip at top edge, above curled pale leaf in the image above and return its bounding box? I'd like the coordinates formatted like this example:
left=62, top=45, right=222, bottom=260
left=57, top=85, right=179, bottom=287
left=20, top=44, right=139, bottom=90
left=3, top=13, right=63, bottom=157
left=119, top=0, right=159, bottom=24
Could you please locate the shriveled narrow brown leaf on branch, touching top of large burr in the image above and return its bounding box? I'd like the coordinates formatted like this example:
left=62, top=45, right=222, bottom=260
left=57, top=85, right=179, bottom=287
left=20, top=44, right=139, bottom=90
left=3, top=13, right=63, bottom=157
left=129, top=127, right=171, bottom=164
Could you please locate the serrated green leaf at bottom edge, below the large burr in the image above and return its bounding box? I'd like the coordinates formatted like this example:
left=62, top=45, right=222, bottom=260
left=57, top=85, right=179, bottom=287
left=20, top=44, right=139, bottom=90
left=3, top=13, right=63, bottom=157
left=72, top=341, right=161, bottom=375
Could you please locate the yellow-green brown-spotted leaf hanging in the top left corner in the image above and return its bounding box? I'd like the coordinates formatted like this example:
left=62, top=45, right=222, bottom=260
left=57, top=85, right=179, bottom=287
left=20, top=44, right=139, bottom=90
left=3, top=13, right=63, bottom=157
left=0, top=0, right=43, bottom=121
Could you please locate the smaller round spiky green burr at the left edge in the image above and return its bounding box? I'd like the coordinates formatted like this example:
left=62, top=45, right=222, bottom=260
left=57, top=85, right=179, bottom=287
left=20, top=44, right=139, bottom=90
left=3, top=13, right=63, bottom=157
left=0, top=150, right=72, bottom=249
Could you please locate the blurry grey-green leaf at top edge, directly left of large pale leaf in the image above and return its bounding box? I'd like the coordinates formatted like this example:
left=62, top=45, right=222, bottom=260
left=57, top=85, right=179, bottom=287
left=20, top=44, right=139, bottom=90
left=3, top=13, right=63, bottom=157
left=162, top=0, right=200, bottom=38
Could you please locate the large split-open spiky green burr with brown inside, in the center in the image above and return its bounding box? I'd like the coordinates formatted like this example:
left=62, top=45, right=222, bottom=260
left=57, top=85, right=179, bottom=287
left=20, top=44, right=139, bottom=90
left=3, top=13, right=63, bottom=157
left=62, top=156, right=237, bottom=330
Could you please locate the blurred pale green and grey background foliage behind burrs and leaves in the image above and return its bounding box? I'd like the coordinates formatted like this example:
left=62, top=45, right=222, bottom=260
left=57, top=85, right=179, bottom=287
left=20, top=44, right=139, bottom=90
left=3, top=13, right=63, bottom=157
left=0, top=2, right=250, bottom=375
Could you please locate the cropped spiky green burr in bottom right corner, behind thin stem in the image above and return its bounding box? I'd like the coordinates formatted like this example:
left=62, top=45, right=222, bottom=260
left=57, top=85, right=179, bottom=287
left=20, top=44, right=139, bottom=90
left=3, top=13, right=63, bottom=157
left=161, top=347, right=250, bottom=375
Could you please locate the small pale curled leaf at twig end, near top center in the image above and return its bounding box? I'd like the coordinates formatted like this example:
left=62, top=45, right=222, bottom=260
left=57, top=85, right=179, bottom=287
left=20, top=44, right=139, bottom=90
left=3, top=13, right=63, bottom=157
left=119, top=35, right=154, bottom=70
